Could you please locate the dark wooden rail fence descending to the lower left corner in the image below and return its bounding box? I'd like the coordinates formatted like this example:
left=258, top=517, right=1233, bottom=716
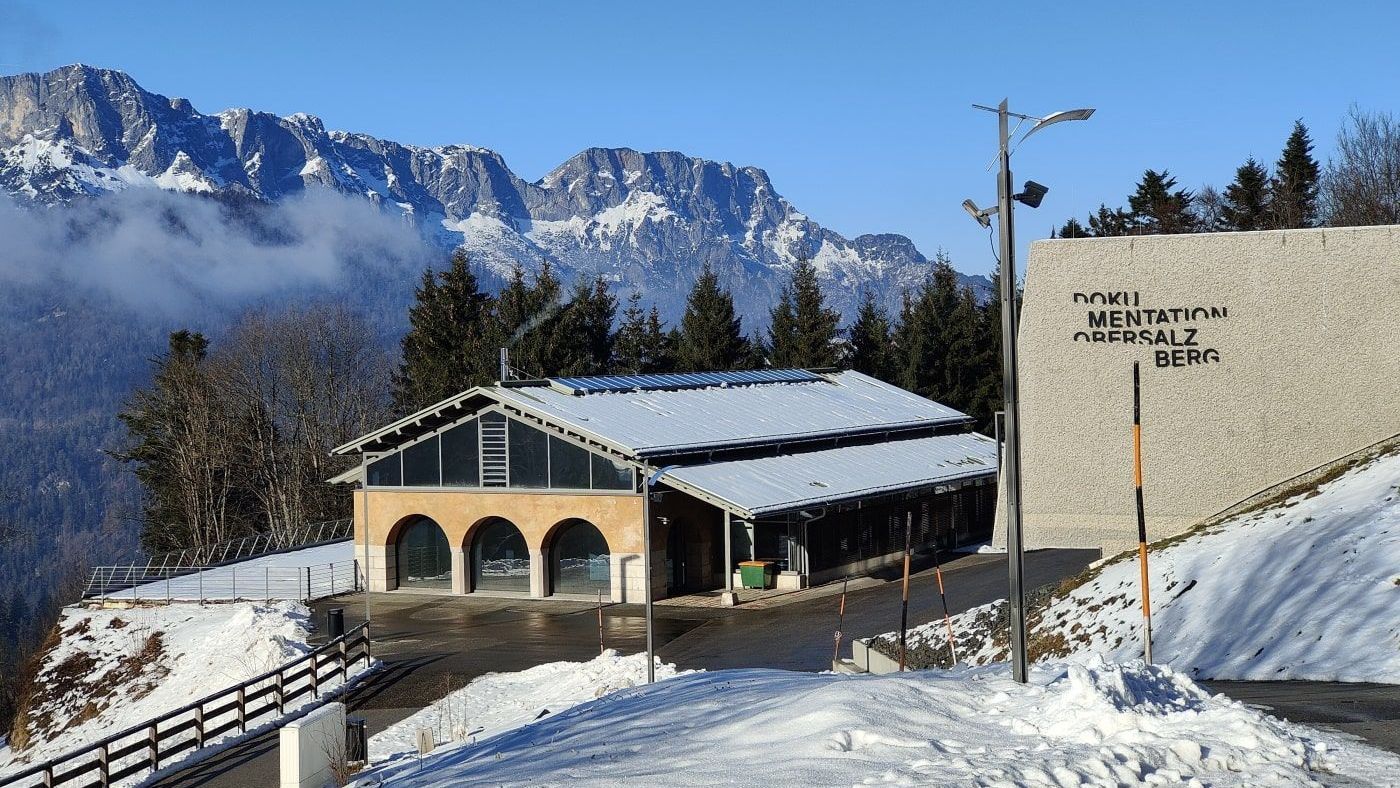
left=0, top=623, right=371, bottom=788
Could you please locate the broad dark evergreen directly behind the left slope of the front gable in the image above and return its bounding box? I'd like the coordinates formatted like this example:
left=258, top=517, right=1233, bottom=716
left=393, top=251, right=496, bottom=414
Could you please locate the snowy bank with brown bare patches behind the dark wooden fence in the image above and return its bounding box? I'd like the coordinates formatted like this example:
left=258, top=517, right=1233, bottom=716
left=0, top=602, right=350, bottom=777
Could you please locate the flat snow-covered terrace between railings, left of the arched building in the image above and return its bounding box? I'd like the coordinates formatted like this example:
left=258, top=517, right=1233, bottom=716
left=105, top=540, right=356, bottom=600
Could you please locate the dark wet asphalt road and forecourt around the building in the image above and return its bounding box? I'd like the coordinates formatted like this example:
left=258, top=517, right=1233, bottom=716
left=157, top=550, right=1400, bottom=788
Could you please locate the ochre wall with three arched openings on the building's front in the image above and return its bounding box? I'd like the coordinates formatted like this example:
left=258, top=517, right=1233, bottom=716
left=354, top=488, right=649, bottom=602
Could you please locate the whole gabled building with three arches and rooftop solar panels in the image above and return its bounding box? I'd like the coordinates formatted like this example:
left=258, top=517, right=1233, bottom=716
left=333, top=370, right=997, bottom=602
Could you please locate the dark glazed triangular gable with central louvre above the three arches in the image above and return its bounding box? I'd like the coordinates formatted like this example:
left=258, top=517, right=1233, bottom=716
left=365, top=414, right=636, bottom=493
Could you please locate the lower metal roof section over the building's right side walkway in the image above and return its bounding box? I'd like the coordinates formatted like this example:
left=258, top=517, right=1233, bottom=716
left=659, top=432, right=997, bottom=519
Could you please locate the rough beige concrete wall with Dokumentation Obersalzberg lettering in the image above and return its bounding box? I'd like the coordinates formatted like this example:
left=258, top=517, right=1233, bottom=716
left=995, top=227, right=1400, bottom=551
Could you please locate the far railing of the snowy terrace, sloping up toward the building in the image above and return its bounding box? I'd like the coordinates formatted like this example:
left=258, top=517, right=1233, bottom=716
left=83, top=519, right=354, bottom=599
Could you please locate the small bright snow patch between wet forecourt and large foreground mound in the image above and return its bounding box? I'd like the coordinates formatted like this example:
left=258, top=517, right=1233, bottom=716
left=370, top=649, right=690, bottom=761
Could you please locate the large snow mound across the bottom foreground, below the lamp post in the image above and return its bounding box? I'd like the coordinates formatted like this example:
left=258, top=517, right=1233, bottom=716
left=356, top=662, right=1400, bottom=788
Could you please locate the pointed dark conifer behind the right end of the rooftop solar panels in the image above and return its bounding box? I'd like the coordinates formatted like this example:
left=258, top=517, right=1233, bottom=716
left=769, top=258, right=841, bottom=370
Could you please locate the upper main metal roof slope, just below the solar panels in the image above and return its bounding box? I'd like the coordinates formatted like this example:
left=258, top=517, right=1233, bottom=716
left=490, top=371, right=969, bottom=458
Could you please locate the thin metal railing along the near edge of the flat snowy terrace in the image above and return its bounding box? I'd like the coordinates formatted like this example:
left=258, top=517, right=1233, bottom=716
left=83, top=558, right=360, bottom=603
